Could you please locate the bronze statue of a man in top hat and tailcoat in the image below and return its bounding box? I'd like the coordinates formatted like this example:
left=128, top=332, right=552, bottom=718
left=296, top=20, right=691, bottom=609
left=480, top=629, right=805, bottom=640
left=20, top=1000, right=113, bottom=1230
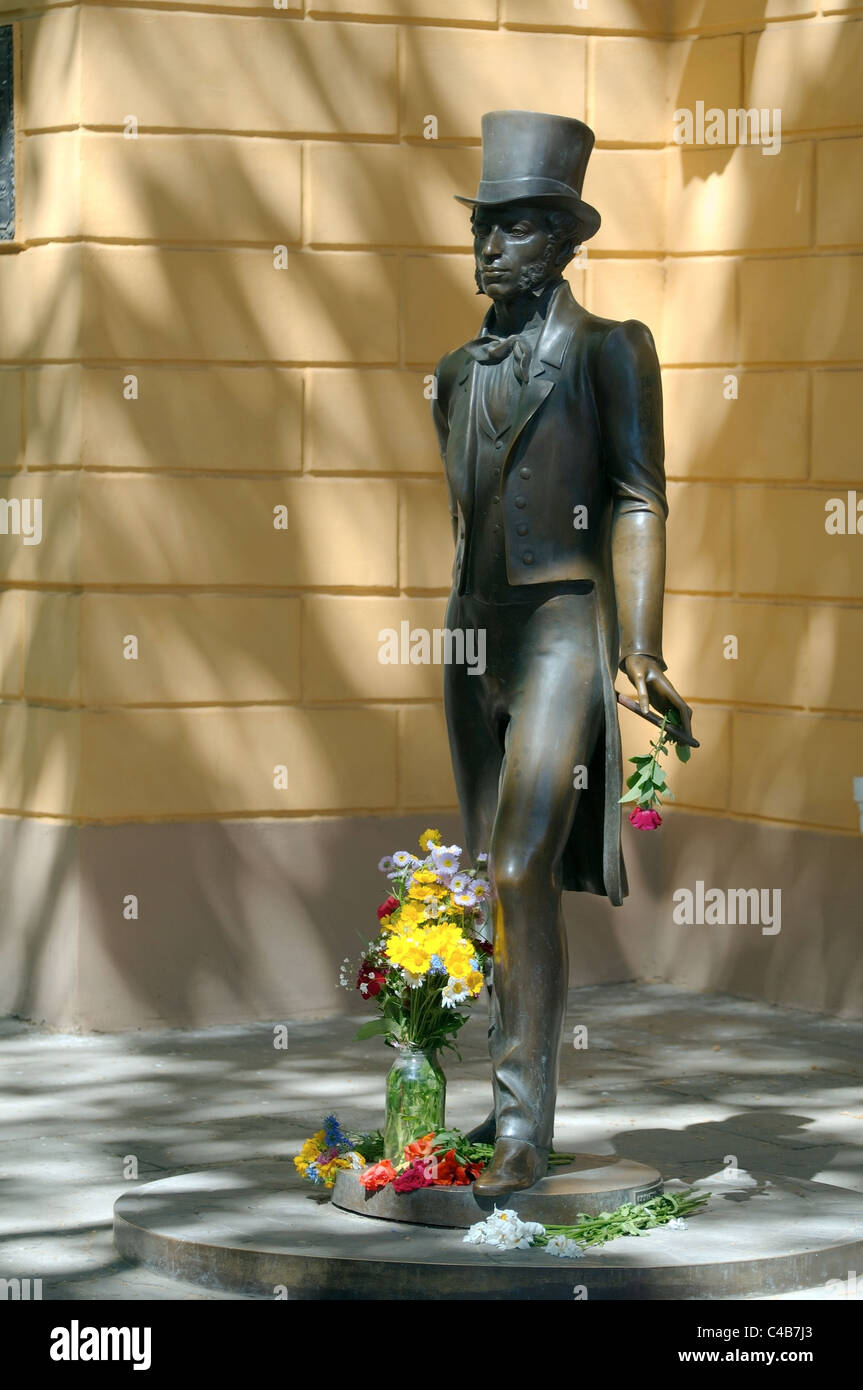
left=434, top=111, right=691, bottom=1197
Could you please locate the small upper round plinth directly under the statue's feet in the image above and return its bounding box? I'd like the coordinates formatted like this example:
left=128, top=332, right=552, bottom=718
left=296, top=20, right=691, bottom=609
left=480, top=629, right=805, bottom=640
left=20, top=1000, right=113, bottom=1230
left=332, top=1154, right=663, bottom=1230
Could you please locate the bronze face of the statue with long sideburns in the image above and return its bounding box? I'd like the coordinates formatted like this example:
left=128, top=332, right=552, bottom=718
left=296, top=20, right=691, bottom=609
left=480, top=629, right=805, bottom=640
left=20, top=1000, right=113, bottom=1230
left=474, top=203, right=559, bottom=300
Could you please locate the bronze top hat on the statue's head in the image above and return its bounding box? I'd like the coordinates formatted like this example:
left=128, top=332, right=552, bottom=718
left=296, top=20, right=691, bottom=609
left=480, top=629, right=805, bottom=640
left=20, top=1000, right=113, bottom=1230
left=456, top=111, right=600, bottom=242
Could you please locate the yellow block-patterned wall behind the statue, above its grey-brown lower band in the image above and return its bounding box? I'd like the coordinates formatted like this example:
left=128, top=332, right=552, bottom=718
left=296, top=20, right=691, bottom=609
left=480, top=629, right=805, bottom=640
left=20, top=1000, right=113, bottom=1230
left=0, top=0, right=863, bottom=848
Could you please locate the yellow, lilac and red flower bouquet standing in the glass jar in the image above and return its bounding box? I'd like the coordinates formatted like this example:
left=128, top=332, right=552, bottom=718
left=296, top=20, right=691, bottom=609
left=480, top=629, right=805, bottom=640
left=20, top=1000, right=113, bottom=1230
left=339, top=830, right=492, bottom=1052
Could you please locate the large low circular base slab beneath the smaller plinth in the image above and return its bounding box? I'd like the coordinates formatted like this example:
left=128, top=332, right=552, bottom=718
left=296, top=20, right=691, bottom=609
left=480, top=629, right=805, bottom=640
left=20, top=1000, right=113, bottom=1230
left=114, top=1159, right=863, bottom=1302
